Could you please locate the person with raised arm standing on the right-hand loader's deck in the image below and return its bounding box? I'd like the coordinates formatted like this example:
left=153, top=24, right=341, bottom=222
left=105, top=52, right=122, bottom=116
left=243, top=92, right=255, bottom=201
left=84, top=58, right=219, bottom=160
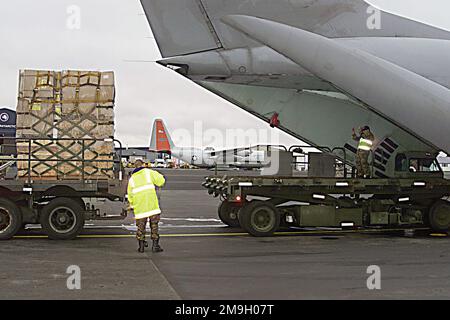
left=352, top=126, right=375, bottom=178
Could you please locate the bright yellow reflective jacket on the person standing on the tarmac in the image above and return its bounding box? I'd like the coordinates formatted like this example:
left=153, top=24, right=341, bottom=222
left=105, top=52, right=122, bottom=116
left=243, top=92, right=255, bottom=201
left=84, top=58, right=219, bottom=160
left=128, top=168, right=166, bottom=219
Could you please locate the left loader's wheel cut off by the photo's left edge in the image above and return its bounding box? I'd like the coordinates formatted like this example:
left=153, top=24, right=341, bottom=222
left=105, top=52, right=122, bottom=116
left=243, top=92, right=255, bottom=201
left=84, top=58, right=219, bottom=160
left=0, top=198, right=22, bottom=240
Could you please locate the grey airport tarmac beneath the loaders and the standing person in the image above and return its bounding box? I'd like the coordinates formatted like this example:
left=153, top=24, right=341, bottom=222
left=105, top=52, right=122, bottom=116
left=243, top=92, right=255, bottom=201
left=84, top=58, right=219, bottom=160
left=0, top=170, right=450, bottom=300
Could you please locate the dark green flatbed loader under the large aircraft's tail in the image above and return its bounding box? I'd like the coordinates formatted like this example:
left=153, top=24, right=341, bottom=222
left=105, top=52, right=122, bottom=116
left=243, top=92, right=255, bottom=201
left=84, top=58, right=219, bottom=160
left=203, top=149, right=450, bottom=237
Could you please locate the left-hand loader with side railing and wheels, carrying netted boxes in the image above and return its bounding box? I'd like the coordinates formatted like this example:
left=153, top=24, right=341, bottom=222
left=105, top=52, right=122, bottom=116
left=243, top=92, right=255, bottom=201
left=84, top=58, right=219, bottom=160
left=0, top=138, right=128, bottom=240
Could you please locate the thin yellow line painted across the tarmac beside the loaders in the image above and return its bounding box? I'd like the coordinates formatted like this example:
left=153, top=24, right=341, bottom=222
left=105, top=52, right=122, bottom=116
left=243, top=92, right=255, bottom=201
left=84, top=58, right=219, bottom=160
left=14, top=228, right=429, bottom=239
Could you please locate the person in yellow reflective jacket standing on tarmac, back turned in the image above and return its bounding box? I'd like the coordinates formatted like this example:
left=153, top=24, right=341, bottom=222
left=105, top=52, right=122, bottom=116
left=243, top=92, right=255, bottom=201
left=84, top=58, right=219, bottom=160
left=128, top=160, right=166, bottom=253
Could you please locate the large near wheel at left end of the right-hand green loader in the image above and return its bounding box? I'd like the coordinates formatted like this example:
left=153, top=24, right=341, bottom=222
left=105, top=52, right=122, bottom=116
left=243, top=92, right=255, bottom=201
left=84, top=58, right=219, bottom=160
left=238, top=201, right=281, bottom=237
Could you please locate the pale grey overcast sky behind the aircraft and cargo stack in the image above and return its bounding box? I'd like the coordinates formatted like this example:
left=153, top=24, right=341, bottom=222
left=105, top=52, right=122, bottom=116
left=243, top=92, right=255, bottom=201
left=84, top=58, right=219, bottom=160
left=0, top=0, right=450, bottom=147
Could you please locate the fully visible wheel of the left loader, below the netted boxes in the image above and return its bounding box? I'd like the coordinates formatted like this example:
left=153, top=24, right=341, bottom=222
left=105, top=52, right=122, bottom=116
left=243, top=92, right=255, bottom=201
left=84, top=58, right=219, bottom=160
left=39, top=198, right=84, bottom=240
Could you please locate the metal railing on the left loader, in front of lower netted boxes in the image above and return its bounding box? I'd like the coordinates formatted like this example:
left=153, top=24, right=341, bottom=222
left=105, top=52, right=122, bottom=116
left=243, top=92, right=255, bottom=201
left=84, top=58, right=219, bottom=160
left=0, top=137, right=124, bottom=184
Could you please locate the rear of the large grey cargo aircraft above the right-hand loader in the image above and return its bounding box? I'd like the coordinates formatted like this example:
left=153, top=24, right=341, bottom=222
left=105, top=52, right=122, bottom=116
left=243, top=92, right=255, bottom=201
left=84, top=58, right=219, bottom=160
left=141, top=0, right=450, bottom=235
